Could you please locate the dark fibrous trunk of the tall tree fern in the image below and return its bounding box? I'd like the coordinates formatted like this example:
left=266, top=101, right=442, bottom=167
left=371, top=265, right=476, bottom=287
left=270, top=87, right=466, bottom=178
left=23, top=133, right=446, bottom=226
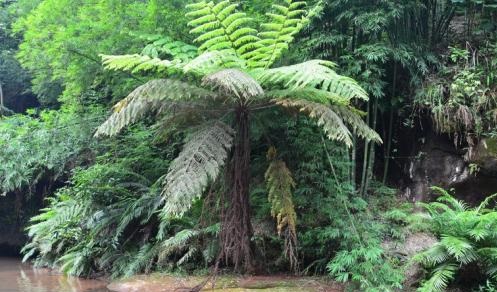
left=219, top=107, right=253, bottom=273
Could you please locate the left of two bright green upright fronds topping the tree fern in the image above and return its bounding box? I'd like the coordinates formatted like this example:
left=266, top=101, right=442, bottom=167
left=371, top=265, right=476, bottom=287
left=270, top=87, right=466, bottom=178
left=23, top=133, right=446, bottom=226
left=187, top=0, right=259, bottom=58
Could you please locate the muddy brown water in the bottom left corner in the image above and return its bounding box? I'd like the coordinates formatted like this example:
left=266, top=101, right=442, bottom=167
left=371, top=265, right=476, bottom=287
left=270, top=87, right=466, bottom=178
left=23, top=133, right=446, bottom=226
left=0, top=258, right=110, bottom=292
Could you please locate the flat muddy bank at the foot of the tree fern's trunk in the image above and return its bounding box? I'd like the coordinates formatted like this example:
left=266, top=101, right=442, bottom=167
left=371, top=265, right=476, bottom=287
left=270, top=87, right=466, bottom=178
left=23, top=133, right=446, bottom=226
left=108, top=273, right=344, bottom=292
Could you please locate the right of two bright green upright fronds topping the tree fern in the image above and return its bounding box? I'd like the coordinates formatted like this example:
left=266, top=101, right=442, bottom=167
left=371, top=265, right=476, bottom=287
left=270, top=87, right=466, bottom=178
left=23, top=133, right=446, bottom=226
left=245, top=0, right=306, bottom=68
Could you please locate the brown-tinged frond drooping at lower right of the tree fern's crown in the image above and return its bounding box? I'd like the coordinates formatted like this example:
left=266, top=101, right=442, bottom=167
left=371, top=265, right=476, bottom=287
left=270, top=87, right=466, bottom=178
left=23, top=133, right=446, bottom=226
left=274, top=99, right=352, bottom=147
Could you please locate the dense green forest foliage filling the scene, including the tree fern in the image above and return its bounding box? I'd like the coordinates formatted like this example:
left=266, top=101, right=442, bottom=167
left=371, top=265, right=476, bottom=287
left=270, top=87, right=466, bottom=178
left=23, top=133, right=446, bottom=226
left=0, top=0, right=497, bottom=291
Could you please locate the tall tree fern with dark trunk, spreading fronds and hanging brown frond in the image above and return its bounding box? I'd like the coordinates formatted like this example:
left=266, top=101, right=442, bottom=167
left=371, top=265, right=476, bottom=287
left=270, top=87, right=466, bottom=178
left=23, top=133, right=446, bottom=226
left=96, top=0, right=381, bottom=271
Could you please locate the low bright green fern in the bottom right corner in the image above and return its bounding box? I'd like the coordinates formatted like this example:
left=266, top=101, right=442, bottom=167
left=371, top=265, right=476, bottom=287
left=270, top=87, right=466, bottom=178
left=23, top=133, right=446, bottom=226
left=414, top=187, right=497, bottom=292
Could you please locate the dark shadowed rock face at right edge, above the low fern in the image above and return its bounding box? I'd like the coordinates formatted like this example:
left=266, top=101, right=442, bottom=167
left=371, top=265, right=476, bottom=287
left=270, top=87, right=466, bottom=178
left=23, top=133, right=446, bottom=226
left=401, top=132, right=497, bottom=204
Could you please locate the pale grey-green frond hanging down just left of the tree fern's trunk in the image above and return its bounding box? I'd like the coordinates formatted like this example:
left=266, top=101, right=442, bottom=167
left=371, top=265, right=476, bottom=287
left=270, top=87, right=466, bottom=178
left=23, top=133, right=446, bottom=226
left=162, top=122, right=234, bottom=216
